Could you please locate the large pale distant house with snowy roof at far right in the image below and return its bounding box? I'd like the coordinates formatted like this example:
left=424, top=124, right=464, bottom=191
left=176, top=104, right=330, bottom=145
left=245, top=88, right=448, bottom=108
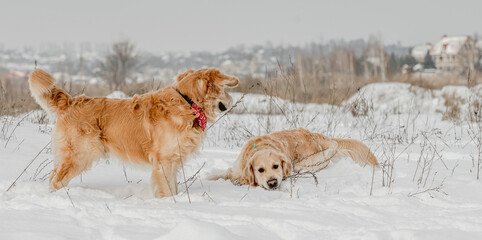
left=430, top=36, right=479, bottom=73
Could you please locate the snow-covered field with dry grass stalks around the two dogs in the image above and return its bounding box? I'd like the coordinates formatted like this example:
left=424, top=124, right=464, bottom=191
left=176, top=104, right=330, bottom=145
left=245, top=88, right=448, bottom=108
left=0, top=83, right=482, bottom=240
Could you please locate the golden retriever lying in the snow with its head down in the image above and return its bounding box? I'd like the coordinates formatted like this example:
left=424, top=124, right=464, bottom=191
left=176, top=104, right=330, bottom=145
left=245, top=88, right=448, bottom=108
left=209, top=128, right=378, bottom=190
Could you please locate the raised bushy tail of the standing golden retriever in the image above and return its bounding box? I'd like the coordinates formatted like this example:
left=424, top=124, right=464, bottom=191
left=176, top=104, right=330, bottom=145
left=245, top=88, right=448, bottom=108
left=28, top=69, right=71, bottom=114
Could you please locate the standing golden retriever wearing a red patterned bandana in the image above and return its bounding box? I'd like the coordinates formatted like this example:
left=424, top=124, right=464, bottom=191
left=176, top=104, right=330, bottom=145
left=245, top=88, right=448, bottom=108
left=29, top=69, right=239, bottom=197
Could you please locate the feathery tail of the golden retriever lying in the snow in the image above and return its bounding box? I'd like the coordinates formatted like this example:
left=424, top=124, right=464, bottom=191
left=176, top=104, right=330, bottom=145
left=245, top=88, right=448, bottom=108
left=333, top=138, right=380, bottom=167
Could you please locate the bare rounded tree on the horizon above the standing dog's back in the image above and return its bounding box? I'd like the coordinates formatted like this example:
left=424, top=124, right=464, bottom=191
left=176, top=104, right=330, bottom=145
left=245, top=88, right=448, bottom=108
left=101, top=40, right=139, bottom=90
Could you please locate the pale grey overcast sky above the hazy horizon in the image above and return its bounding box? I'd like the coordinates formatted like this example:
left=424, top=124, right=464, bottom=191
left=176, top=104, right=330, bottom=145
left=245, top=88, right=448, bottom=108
left=0, top=0, right=482, bottom=51
